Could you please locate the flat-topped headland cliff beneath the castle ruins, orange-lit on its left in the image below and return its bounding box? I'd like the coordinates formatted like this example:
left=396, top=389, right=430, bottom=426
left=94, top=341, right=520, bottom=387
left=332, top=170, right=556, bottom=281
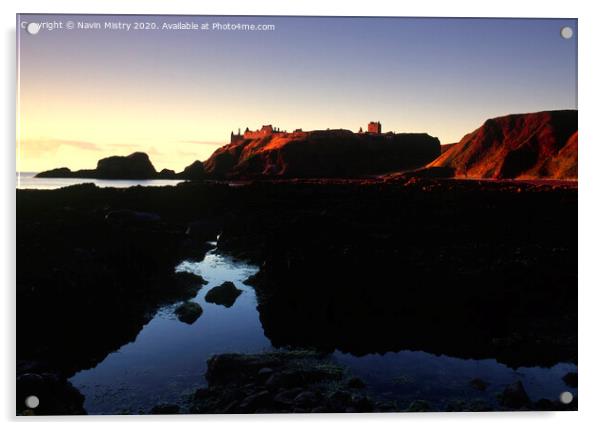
left=204, top=130, right=441, bottom=178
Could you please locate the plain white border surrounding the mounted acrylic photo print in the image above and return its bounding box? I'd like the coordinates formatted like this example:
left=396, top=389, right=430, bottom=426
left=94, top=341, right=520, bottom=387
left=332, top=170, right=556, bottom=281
left=0, top=0, right=602, bottom=430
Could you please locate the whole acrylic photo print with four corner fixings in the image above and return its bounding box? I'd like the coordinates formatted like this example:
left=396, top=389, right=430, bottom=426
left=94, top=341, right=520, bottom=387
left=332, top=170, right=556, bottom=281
left=15, top=14, right=578, bottom=415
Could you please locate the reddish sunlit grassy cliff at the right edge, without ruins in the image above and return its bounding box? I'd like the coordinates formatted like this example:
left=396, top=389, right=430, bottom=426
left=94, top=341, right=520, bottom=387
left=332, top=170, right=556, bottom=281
left=429, top=110, right=577, bottom=179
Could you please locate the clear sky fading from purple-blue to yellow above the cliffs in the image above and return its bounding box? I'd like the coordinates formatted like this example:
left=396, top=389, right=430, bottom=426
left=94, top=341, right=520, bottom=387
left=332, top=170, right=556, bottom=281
left=17, top=14, right=577, bottom=172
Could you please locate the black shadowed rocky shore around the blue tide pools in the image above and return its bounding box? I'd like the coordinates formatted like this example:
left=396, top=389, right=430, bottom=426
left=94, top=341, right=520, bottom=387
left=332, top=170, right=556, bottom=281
left=17, top=177, right=577, bottom=414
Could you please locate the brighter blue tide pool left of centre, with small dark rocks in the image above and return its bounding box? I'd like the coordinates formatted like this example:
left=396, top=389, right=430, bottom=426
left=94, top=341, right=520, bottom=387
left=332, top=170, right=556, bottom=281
left=71, top=252, right=270, bottom=414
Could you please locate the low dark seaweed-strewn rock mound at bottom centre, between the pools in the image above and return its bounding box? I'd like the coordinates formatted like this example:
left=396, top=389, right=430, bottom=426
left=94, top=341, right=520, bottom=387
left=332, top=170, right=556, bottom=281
left=191, top=350, right=392, bottom=414
